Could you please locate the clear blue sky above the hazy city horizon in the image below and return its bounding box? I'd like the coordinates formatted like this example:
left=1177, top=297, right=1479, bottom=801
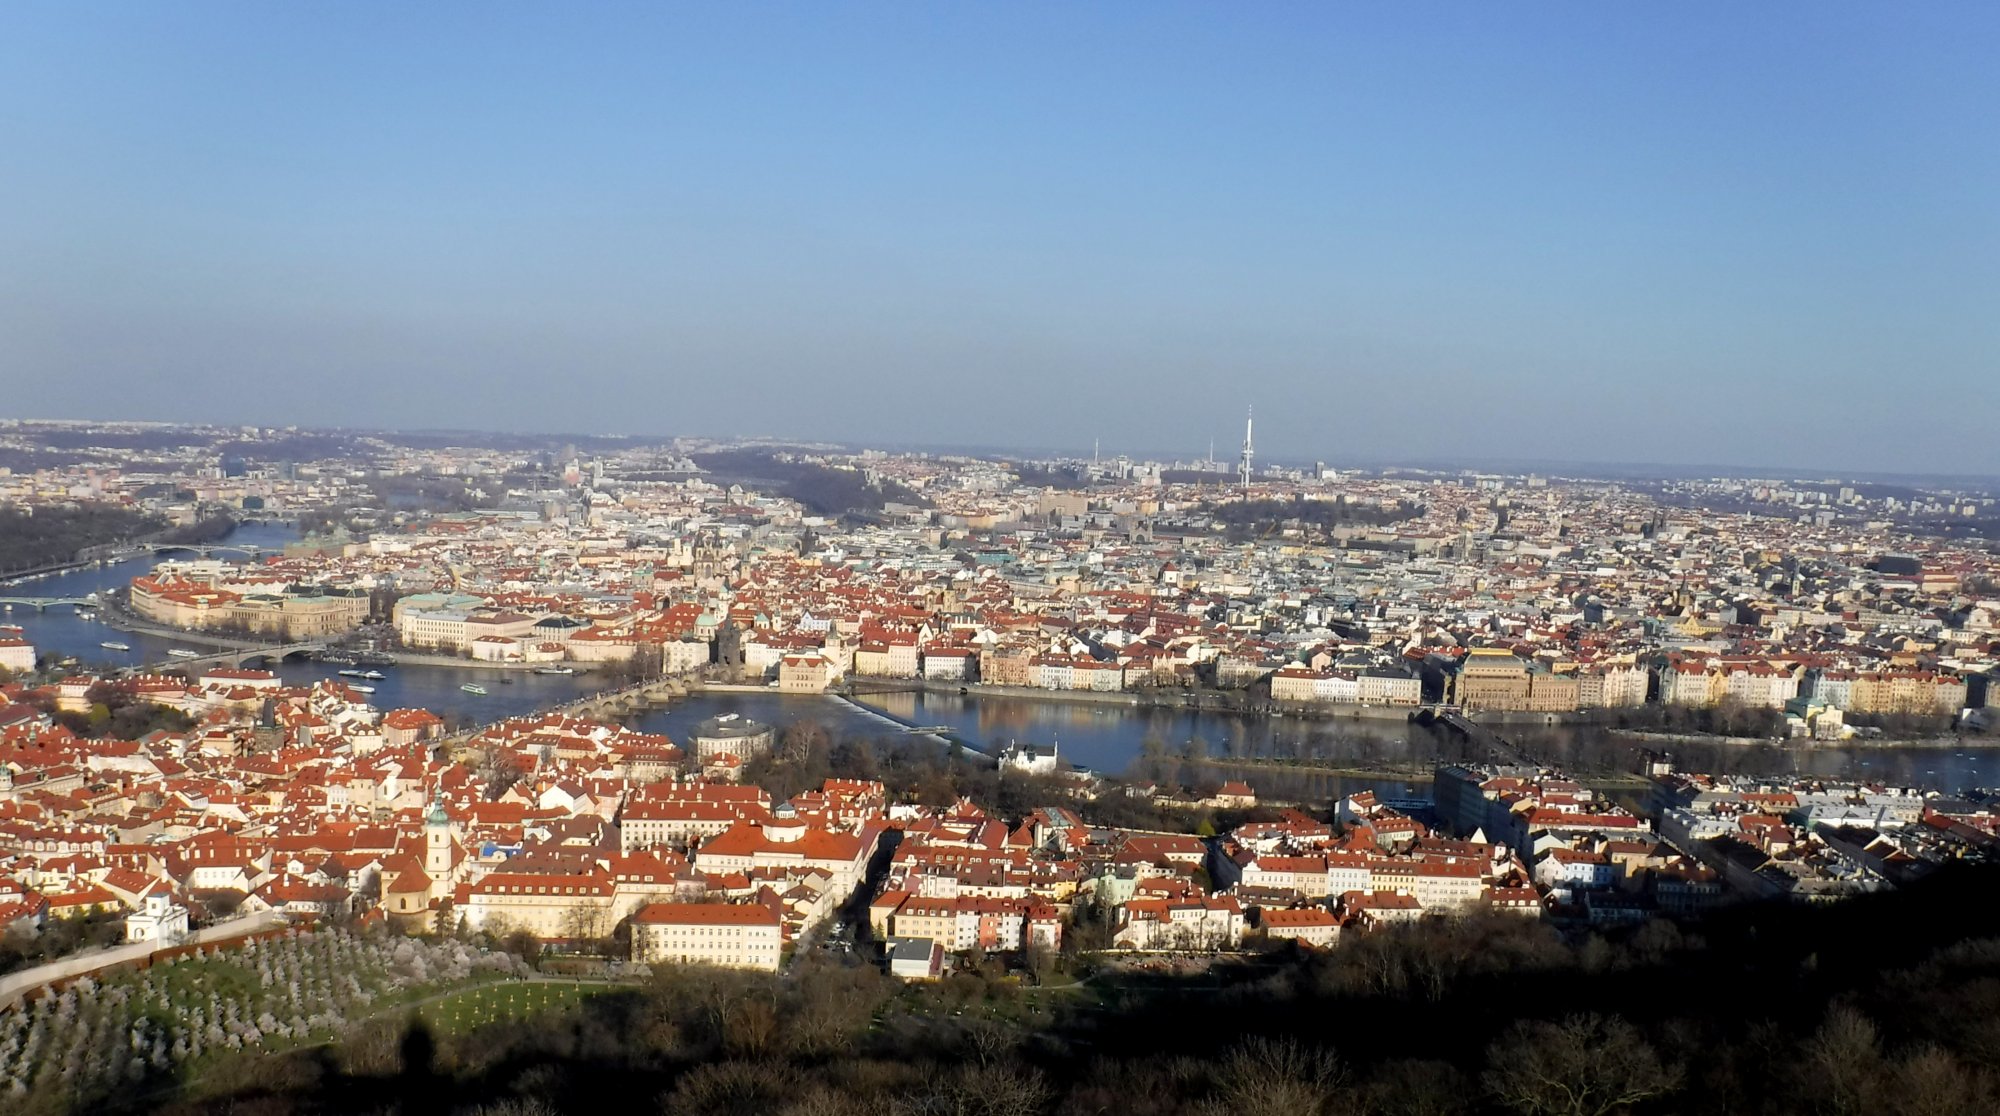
left=0, top=2, right=2000, bottom=474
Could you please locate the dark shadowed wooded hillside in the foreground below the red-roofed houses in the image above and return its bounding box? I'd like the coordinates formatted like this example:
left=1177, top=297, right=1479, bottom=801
left=125, top=868, right=2000, bottom=1116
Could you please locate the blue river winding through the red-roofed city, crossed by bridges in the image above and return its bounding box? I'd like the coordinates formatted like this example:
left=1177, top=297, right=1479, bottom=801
left=0, top=524, right=2000, bottom=794
